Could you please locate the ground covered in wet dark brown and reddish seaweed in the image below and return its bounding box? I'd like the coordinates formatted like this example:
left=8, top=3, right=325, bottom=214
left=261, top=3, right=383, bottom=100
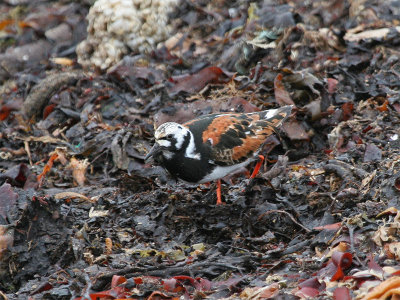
left=0, top=1, right=400, bottom=299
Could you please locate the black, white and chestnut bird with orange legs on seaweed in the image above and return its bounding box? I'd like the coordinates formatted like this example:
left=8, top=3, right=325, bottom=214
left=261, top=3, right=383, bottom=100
left=144, top=105, right=293, bottom=205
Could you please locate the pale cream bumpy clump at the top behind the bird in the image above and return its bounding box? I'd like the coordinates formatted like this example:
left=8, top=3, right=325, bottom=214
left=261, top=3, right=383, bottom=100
left=76, top=0, right=179, bottom=69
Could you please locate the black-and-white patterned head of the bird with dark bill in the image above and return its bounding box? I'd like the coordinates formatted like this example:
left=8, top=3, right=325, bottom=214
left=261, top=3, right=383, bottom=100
left=145, top=122, right=190, bottom=163
